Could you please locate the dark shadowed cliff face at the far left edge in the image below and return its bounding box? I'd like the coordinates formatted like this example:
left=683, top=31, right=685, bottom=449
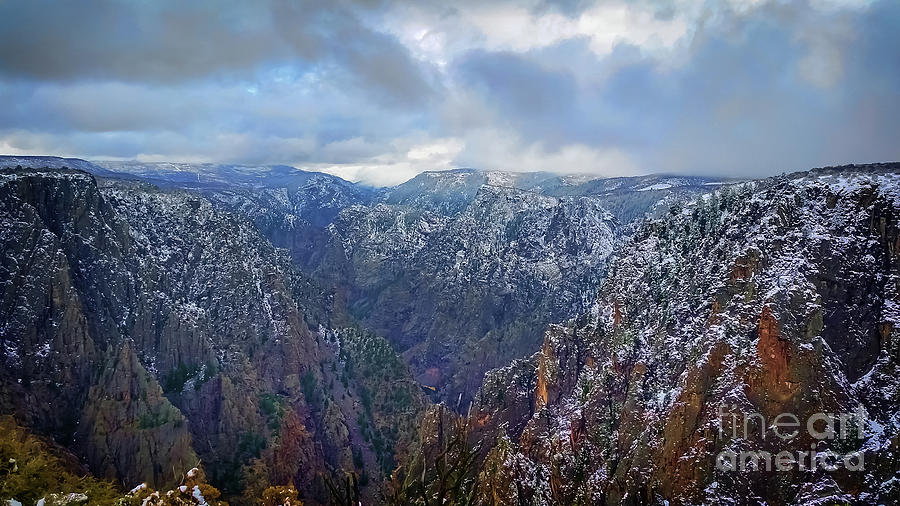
left=0, top=173, right=102, bottom=438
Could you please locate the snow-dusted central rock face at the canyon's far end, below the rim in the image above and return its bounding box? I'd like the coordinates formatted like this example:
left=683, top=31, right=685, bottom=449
left=317, top=186, right=618, bottom=403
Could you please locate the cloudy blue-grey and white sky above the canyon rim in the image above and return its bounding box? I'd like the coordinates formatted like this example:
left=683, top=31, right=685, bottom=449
left=0, top=0, right=900, bottom=185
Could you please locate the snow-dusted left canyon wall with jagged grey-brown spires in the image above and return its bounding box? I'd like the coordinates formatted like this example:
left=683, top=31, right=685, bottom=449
left=0, top=169, right=422, bottom=500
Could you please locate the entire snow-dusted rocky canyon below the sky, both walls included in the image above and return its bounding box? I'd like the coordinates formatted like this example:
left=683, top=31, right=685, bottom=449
left=0, top=156, right=900, bottom=504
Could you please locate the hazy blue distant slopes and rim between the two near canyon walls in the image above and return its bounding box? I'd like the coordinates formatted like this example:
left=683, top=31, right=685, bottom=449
left=0, top=158, right=719, bottom=412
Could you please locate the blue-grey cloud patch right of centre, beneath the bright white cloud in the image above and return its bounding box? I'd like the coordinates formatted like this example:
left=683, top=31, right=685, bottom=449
left=456, top=38, right=648, bottom=150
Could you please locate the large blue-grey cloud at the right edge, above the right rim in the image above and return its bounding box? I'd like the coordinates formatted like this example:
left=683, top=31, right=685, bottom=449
left=636, top=1, right=900, bottom=176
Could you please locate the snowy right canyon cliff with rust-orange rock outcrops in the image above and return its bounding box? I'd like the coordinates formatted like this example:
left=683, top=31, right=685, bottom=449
left=404, top=164, right=900, bottom=504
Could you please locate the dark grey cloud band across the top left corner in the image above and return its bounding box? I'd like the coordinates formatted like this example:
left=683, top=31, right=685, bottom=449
left=0, top=0, right=432, bottom=105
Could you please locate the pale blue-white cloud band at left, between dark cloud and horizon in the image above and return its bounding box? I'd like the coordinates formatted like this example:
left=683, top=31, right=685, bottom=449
left=0, top=74, right=422, bottom=163
